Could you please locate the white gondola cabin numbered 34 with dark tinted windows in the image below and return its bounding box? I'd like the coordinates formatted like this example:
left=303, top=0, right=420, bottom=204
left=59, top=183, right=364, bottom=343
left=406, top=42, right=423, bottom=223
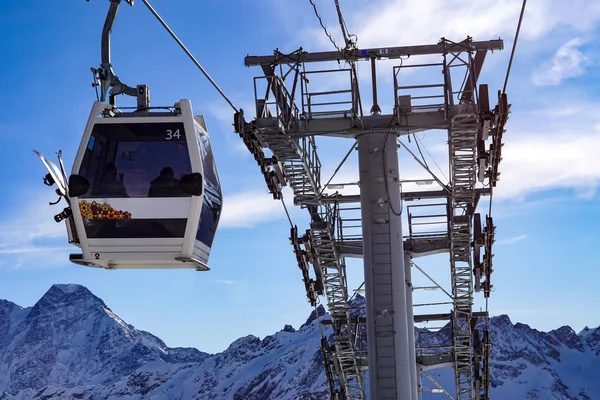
left=67, top=100, right=222, bottom=270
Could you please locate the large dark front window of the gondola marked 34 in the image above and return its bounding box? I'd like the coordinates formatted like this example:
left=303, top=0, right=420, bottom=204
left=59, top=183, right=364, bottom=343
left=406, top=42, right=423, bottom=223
left=79, top=122, right=192, bottom=198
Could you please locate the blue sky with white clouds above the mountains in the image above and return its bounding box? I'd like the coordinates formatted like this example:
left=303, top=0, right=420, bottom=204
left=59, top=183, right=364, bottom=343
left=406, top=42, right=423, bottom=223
left=0, top=0, right=600, bottom=352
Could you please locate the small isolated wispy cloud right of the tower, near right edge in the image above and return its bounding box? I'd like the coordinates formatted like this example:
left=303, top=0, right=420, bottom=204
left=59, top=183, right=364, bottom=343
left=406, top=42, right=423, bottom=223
left=532, top=38, right=588, bottom=86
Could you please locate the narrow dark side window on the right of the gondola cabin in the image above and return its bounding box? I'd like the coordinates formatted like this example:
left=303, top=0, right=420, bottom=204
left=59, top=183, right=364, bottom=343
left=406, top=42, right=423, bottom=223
left=194, top=122, right=223, bottom=247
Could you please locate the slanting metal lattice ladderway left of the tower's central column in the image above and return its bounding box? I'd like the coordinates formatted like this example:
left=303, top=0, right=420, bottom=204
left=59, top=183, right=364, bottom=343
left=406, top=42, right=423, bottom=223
left=254, top=76, right=365, bottom=400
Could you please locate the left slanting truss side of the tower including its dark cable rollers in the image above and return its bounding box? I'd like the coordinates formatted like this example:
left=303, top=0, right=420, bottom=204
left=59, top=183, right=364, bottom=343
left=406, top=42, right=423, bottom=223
left=235, top=56, right=365, bottom=400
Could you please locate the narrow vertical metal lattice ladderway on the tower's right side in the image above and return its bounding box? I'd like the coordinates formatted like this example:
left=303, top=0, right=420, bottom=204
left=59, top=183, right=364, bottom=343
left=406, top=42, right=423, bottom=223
left=443, top=40, right=480, bottom=400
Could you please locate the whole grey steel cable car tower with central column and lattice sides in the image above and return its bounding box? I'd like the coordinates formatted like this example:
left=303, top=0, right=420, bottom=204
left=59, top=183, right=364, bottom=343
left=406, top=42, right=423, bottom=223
left=234, top=38, right=509, bottom=400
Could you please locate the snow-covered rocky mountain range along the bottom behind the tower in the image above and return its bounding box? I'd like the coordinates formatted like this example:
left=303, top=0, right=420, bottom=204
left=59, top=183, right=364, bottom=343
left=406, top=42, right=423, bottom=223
left=0, top=285, right=600, bottom=400
